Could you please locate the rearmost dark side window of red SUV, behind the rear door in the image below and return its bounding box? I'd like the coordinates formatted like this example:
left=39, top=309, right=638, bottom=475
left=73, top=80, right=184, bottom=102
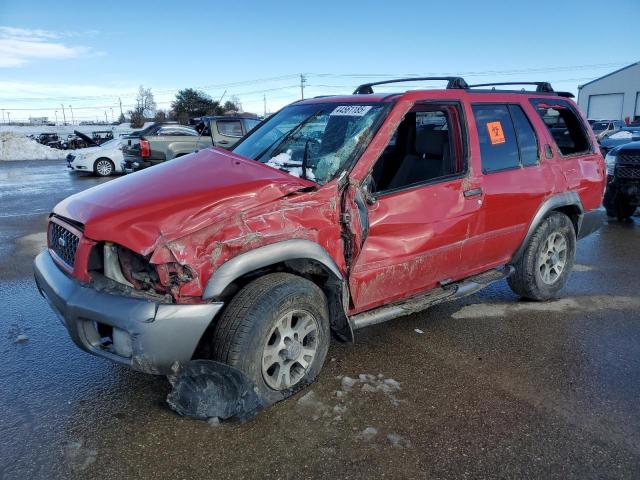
left=531, top=98, right=596, bottom=155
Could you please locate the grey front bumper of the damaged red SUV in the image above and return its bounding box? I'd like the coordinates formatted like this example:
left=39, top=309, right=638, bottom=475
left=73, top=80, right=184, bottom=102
left=33, top=251, right=223, bottom=374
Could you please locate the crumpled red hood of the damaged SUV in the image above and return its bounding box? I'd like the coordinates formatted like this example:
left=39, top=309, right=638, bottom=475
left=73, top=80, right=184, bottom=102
left=53, top=148, right=315, bottom=255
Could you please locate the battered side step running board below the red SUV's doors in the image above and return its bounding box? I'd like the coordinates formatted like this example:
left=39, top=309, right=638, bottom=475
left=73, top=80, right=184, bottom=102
left=349, top=265, right=513, bottom=330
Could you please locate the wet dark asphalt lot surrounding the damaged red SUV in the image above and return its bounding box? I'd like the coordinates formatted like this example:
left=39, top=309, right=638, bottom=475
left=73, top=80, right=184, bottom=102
left=0, top=161, right=640, bottom=479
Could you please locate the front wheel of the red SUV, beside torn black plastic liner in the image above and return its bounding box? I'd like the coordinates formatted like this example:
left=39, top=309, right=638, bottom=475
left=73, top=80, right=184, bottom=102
left=212, top=273, right=331, bottom=402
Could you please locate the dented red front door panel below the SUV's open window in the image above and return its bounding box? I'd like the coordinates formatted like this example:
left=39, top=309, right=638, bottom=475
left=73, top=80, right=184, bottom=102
left=349, top=178, right=478, bottom=313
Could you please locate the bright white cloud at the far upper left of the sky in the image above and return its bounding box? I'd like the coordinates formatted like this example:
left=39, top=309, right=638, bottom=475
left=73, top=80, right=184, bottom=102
left=0, top=26, right=95, bottom=68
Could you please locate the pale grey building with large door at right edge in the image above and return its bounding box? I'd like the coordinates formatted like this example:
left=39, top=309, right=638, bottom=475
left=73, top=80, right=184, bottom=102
left=578, top=62, right=640, bottom=121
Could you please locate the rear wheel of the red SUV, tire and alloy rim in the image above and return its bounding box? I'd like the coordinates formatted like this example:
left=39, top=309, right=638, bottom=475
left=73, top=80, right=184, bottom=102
left=507, top=212, right=576, bottom=301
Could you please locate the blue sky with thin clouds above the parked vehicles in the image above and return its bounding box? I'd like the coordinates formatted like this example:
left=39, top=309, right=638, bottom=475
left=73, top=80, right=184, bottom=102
left=0, top=0, right=640, bottom=119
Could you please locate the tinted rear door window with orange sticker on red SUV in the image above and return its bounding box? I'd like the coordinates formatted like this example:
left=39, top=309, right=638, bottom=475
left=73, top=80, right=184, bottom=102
left=473, top=105, right=520, bottom=173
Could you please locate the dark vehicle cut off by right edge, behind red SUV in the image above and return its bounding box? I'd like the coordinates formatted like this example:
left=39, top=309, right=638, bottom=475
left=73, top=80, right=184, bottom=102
left=603, top=139, right=640, bottom=221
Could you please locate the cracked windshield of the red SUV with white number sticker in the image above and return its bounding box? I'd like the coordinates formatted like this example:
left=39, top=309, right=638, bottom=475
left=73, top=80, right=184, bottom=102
left=233, top=103, right=385, bottom=185
